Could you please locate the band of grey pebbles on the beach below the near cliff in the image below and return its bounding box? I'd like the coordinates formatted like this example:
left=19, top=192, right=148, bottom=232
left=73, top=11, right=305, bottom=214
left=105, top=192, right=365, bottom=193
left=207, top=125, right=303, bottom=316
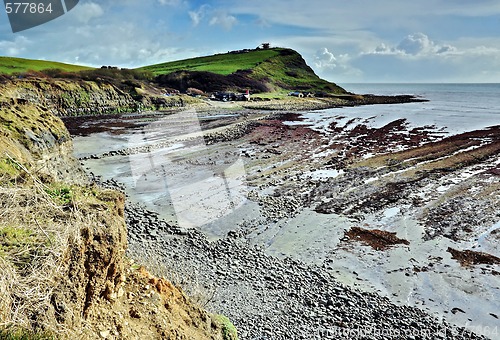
left=120, top=204, right=485, bottom=340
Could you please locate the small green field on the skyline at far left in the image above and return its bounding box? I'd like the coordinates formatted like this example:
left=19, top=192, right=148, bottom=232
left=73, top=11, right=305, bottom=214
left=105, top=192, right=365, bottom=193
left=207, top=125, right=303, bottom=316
left=0, top=57, right=92, bottom=74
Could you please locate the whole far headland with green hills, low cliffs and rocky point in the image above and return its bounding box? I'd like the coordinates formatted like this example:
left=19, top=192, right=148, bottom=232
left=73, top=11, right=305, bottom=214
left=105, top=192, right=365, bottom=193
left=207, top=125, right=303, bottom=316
left=0, top=48, right=422, bottom=116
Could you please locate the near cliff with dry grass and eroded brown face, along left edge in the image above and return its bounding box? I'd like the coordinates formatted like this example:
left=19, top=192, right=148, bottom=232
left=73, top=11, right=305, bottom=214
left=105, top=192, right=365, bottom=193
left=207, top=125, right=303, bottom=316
left=0, top=79, right=232, bottom=339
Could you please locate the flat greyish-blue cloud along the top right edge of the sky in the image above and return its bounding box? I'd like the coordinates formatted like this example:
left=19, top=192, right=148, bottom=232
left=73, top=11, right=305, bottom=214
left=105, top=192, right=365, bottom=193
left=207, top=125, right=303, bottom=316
left=224, top=0, right=500, bottom=32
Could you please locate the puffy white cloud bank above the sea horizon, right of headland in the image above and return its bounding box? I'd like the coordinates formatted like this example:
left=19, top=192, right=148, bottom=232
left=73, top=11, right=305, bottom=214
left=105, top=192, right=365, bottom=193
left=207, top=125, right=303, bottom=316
left=350, top=33, right=500, bottom=82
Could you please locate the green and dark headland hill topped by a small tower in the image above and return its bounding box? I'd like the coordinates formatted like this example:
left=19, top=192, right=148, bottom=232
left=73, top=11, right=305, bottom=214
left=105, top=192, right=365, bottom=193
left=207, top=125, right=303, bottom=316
left=141, top=48, right=346, bottom=94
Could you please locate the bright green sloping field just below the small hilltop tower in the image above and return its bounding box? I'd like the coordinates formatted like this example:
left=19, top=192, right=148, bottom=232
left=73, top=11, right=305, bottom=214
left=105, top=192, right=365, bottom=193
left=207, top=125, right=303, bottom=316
left=140, top=48, right=280, bottom=75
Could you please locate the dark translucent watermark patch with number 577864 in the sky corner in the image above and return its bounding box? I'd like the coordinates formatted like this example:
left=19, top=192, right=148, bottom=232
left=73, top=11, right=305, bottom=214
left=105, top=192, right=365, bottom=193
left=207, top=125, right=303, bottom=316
left=4, top=0, right=79, bottom=33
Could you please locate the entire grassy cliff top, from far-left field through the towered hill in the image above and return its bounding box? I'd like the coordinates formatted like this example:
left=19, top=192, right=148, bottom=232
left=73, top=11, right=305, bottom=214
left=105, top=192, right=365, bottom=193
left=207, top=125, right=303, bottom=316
left=0, top=48, right=346, bottom=94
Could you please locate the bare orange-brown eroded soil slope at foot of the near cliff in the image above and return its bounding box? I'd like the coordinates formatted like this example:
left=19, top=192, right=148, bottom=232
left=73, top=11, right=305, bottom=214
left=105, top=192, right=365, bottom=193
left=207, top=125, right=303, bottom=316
left=84, top=264, right=229, bottom=340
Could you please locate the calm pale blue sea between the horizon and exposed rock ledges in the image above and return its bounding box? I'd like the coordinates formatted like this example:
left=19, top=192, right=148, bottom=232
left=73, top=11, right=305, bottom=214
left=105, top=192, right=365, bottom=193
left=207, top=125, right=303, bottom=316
left=334, top=84, right=500, bottom=133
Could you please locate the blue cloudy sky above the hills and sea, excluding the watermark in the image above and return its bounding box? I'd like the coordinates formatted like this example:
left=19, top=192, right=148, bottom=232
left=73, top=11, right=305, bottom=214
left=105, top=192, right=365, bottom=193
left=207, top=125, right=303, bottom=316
left=0, top=0, right=500, bottom=83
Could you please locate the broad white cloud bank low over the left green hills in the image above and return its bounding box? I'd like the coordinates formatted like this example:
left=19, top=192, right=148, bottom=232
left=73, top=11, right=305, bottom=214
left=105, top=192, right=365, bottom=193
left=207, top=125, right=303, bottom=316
left=8, top=12, right=183, bottom=67
